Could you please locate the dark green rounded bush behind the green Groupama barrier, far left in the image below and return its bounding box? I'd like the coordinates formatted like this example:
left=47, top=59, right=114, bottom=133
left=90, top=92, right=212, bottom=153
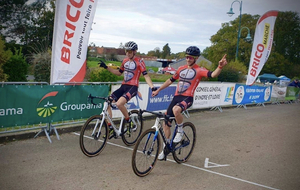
left=3, top=49, right=28, bottom=82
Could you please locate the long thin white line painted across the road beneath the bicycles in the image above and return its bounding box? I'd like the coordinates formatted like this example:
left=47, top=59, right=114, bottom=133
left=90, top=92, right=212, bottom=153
left=73, top=132, right=280, bottom=190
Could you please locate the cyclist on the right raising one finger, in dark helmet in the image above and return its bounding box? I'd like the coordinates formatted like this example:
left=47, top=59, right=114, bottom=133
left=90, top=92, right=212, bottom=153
left=152, top=46, right=227, bottom=160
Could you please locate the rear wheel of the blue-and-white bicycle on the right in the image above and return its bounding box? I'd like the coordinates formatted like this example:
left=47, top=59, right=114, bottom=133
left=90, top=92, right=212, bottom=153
left=172, top=122, right=196, bottom=164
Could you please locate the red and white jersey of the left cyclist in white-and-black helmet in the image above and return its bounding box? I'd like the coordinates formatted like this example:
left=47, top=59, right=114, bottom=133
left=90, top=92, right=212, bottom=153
left=119, top=57, right=147, bottom=86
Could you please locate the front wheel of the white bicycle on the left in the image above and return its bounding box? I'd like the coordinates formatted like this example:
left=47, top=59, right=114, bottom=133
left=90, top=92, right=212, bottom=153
left=79, top=115, right=108, bottom=157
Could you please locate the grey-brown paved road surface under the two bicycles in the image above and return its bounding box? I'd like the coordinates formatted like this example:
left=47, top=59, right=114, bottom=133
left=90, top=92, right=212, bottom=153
left=0, top=104, right=300, bottom=190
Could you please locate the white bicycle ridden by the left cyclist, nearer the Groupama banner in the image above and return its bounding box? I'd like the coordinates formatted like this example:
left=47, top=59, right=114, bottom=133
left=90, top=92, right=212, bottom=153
left=79, top=94, right=143, bottom=157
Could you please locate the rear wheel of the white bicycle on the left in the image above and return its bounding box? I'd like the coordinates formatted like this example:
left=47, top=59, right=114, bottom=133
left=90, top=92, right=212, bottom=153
left=122, top=110, right=143, bottom=146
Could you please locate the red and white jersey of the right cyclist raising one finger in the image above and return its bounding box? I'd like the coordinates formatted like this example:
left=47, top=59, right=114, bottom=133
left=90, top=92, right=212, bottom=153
left=171, top=64, right=210, bottom=97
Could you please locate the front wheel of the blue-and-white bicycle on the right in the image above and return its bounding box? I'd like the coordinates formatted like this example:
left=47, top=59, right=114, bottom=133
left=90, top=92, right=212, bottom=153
left=131, top=129, right=160, bottom=177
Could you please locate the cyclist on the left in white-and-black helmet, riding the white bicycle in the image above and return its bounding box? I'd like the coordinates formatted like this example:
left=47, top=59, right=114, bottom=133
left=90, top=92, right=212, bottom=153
left=100, top=41, right=156, bottom=125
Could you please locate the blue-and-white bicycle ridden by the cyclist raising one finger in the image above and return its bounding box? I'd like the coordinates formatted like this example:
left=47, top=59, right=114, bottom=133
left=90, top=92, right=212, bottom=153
left=131, top=110, right=196, bottom=177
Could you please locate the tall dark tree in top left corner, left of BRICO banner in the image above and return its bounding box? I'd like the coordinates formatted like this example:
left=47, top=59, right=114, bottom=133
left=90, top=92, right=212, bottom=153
left=0, top=0, right=55, bottom=45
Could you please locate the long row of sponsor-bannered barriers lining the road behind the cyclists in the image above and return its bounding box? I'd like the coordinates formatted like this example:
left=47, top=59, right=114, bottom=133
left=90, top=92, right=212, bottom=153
left=0, top=82, right=299, bottom=142
